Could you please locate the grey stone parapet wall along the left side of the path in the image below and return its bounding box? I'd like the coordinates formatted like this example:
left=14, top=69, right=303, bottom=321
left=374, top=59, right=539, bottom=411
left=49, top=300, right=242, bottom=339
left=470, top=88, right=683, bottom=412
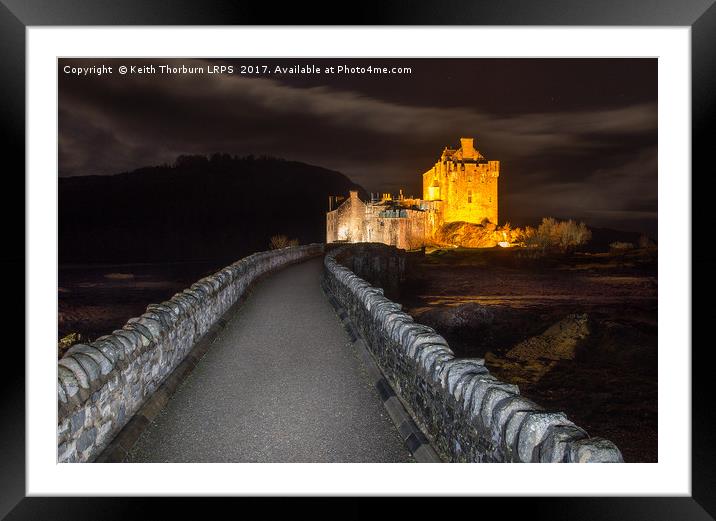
left=57, top=244, right=323, bottom=462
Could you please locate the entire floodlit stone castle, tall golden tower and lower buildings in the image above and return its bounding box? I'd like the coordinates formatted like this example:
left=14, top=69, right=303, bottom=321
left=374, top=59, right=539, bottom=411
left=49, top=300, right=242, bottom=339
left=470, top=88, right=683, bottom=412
left=326, top=138, right=500, bottom=249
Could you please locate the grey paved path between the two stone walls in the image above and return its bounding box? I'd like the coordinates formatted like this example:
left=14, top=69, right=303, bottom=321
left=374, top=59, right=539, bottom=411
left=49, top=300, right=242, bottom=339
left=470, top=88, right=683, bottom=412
left=130, top=259, right=412, bottom=462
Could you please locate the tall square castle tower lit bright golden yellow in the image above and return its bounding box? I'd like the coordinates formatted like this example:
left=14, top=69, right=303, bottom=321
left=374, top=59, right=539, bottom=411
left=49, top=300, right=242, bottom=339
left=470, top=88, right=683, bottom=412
left=423, top=137, right=500, bottom=224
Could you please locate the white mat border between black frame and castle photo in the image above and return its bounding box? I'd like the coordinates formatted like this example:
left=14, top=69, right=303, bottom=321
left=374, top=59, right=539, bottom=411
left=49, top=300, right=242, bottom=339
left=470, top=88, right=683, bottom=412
left=26, top=27, right=691, bottom=495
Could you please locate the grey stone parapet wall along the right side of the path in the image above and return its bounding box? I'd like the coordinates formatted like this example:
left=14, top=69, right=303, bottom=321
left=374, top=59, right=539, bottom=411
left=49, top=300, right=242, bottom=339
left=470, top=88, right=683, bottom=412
left=323, top=246, right=623, bottom=462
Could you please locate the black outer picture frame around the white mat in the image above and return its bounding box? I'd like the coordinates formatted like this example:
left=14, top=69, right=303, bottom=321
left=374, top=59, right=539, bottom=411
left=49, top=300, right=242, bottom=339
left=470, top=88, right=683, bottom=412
left=0, top=0, right=716, bottom=521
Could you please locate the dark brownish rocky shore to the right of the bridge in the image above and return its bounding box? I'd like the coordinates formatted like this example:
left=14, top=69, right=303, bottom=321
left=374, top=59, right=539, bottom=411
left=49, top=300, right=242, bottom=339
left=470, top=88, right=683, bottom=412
left=399, top=249, right=658, bottom=462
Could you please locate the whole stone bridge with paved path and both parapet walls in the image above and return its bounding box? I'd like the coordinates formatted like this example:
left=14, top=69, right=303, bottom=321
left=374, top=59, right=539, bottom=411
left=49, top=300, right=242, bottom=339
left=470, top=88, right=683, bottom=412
left=57, top=244, right=622, bottom=462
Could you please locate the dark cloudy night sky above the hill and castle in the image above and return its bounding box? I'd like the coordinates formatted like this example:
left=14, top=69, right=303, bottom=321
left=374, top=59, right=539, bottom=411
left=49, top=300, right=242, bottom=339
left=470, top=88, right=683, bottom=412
left=59, top=59, right=657, bottom=236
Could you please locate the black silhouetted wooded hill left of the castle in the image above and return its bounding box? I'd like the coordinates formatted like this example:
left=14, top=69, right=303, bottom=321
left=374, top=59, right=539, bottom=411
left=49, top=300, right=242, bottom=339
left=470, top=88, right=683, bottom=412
left=59, top=154, right=366, bottom=263
